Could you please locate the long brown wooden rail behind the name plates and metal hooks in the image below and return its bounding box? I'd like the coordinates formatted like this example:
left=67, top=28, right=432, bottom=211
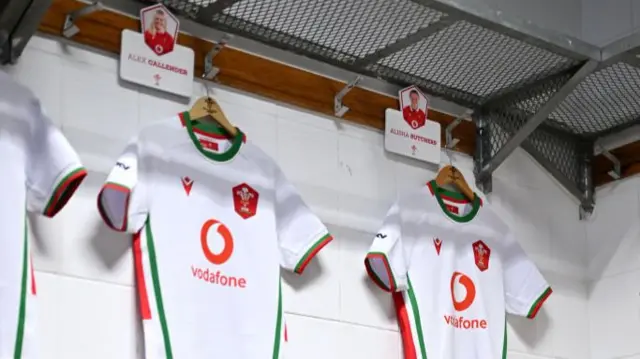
left=39, top=0, right=476, bottom=155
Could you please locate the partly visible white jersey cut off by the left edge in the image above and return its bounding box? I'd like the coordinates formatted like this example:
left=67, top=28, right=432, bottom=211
left=0, top=71, right=86, bottom=359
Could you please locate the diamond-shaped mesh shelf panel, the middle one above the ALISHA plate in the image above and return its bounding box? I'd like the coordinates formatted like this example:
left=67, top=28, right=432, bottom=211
left=370, top=21, right=575, bottom=102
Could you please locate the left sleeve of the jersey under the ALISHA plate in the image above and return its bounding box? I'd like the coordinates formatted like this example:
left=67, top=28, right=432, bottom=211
left=364, top=202, right=408, bottom=292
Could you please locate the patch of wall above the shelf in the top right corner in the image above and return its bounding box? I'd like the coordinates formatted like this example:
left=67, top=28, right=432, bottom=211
left=582, top=0, right=640, bottom=46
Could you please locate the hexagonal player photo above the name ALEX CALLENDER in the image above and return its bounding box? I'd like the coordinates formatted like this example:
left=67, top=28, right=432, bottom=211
left=140, top=4, right=180, bottom=56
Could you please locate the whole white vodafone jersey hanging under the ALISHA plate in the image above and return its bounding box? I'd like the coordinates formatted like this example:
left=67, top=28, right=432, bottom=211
left=365, top=181, right=551, bottom=359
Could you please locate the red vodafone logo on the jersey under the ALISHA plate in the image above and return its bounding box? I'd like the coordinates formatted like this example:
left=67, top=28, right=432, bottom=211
left=444, top=272, right=488, bottom=329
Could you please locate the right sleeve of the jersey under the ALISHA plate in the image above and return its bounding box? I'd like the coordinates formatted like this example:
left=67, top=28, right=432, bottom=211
left=501, top=234, right=552, bottom=319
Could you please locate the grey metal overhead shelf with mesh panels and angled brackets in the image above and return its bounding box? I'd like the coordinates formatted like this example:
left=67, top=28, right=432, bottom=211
left=122, top=0, right=640, bottom=216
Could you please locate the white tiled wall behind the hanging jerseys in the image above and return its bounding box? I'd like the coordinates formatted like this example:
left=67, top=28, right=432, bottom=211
left=8, top=38, right=592, bottom=359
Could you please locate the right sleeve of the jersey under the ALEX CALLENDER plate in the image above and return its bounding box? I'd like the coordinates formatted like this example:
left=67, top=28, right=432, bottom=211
left=275, top=169, right=333, bottom=274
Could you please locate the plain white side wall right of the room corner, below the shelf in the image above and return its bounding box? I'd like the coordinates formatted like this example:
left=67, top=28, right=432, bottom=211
left=587, top=177, right=640, bottom=359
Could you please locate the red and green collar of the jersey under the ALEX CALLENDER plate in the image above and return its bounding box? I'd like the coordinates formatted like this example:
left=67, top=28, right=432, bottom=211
left=179, top=111, right=246, bottom=162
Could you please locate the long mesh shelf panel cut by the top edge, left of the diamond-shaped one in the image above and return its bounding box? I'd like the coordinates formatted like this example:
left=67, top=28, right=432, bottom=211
left=222, top=0, right=445, bottom=61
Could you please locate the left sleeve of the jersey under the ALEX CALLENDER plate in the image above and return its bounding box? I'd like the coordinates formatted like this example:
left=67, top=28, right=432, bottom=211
left=98, top=139, right=148, bottom=233
